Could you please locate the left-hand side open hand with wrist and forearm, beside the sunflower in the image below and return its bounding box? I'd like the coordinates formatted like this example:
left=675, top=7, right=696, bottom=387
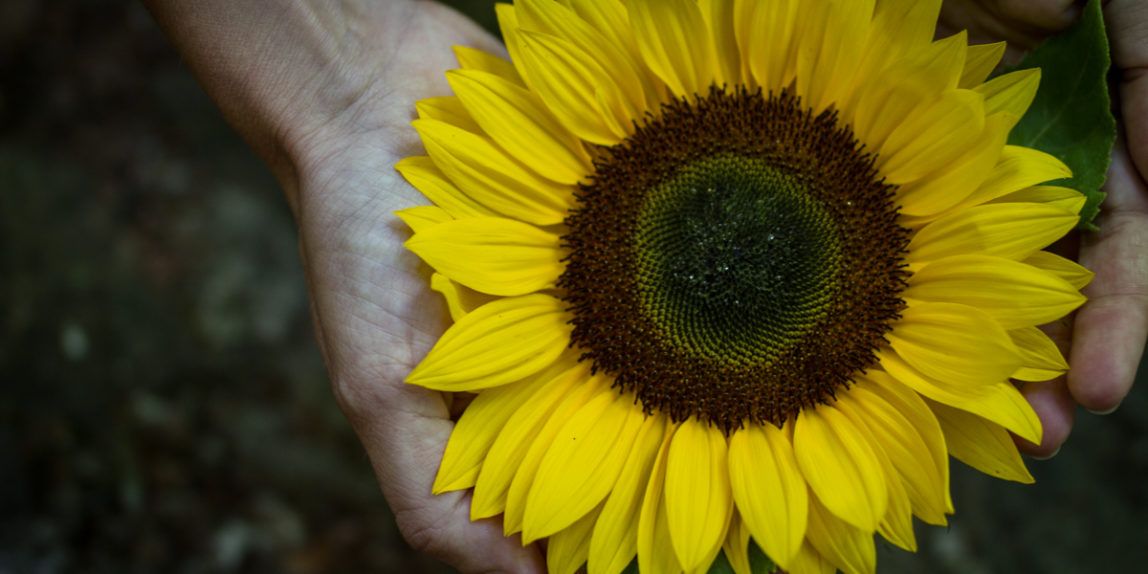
left=148, top=0, right=544, bottom=572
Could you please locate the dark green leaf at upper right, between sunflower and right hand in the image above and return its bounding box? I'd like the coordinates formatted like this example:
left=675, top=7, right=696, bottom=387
left=1009, top=0, right=1116, bottom=231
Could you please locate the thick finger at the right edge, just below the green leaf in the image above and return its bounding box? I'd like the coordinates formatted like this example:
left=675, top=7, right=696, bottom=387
left=1069, top=147, right=1148, bottom=412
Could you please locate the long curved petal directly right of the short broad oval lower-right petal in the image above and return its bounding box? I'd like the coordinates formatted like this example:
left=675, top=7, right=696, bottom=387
left=844, top=371, right=949, bottom=526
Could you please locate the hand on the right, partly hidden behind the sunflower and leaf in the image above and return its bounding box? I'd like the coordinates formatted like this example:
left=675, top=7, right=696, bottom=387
left=943, top=0, right=1148, bottom=457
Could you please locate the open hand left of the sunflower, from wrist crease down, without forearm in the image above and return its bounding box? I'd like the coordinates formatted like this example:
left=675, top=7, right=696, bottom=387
left=280, top=2, right=544, bottom=572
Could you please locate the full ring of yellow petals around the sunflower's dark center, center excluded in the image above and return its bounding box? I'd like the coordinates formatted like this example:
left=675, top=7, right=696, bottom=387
left=397, top=0, right=1091, bottom=574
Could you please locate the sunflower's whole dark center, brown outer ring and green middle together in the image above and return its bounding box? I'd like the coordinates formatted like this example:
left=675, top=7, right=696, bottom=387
left=559, top=88, right=908, bottom=432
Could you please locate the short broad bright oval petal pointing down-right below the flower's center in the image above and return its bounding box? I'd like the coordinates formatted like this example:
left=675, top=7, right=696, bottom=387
left=793, top=405, right=889, bottom=530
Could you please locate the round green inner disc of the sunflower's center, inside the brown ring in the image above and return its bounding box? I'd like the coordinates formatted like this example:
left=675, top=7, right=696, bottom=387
left=635, top=155, right=840, bottom=365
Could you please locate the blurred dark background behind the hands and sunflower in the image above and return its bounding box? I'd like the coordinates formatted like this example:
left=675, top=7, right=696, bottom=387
left=0, top=0, right=1148, bottom=574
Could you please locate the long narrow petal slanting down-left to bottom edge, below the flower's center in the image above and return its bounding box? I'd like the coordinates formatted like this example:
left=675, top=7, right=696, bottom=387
left=588, top=414, right=666, bottom=574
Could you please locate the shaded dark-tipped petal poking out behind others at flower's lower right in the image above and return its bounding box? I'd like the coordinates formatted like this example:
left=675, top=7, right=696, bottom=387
left=929, top=402, right=1039, bottom=484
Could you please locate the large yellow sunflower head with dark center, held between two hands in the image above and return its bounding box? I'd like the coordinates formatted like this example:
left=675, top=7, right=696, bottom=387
left=397, top=0, right=1091, bottom=574
